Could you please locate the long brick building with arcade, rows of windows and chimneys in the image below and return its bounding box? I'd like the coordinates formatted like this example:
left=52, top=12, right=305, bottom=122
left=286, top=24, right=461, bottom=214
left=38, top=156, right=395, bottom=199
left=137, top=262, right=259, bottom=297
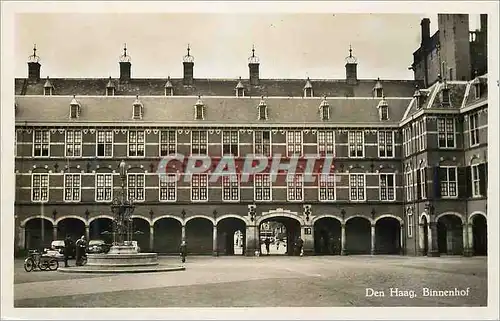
left=15, top=15, right=488, bottom=255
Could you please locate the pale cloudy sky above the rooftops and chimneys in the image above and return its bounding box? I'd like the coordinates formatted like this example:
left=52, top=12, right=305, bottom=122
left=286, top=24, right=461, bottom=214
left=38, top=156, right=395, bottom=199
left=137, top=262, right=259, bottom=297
left=14, top=13, right=477, bottom=79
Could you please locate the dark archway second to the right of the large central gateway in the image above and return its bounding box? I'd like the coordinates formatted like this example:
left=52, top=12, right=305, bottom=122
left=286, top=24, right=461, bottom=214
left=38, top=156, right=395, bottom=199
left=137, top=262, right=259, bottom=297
left=345, top=216, right=371, bottom=254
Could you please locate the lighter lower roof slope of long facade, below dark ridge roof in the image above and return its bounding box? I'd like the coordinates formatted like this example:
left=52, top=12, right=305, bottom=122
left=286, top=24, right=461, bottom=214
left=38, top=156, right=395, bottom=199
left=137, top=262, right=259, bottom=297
left=16, top=96, right=411, bottom=126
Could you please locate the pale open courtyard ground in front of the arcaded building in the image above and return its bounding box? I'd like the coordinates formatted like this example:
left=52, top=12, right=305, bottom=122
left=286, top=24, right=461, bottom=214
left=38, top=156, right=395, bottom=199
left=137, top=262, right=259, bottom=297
left=14, top=256, right=487, bottom=307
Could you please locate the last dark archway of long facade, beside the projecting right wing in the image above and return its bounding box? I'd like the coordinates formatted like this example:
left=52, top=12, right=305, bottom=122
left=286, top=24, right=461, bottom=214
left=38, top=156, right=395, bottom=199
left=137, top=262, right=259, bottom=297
left=375, top=216, right=401, bottom=254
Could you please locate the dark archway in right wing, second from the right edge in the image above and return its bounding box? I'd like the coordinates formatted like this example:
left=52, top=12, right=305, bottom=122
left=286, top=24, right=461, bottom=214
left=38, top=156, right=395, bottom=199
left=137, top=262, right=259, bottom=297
left=437, top=214, right=463, bottom=255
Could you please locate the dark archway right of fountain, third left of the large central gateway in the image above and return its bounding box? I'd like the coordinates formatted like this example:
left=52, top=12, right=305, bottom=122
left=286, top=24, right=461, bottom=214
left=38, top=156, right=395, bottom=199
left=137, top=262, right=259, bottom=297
left=153, top=217, right=182, bottom=255
